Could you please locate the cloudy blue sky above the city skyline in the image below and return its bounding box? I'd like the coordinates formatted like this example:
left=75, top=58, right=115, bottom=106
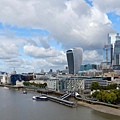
left=0, top=0, right=120, bottom=73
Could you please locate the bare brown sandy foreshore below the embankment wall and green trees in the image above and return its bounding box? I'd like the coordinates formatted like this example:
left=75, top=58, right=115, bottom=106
left=77, top=101, right=120, bottom=116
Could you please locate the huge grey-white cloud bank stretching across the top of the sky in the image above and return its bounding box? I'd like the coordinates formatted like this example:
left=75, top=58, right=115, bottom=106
left=0, top=0, right=113, bottom=49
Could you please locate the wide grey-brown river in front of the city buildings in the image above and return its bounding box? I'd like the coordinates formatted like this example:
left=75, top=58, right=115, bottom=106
left=0, top=87, right=120, bottom=120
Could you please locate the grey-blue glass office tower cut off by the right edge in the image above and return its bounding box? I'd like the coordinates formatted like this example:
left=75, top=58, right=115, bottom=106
left=114, top=36, right=120, bottom=65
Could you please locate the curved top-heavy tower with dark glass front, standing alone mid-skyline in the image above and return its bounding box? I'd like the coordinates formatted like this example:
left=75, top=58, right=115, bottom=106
left=66, top=48, right=83, bottom=74
